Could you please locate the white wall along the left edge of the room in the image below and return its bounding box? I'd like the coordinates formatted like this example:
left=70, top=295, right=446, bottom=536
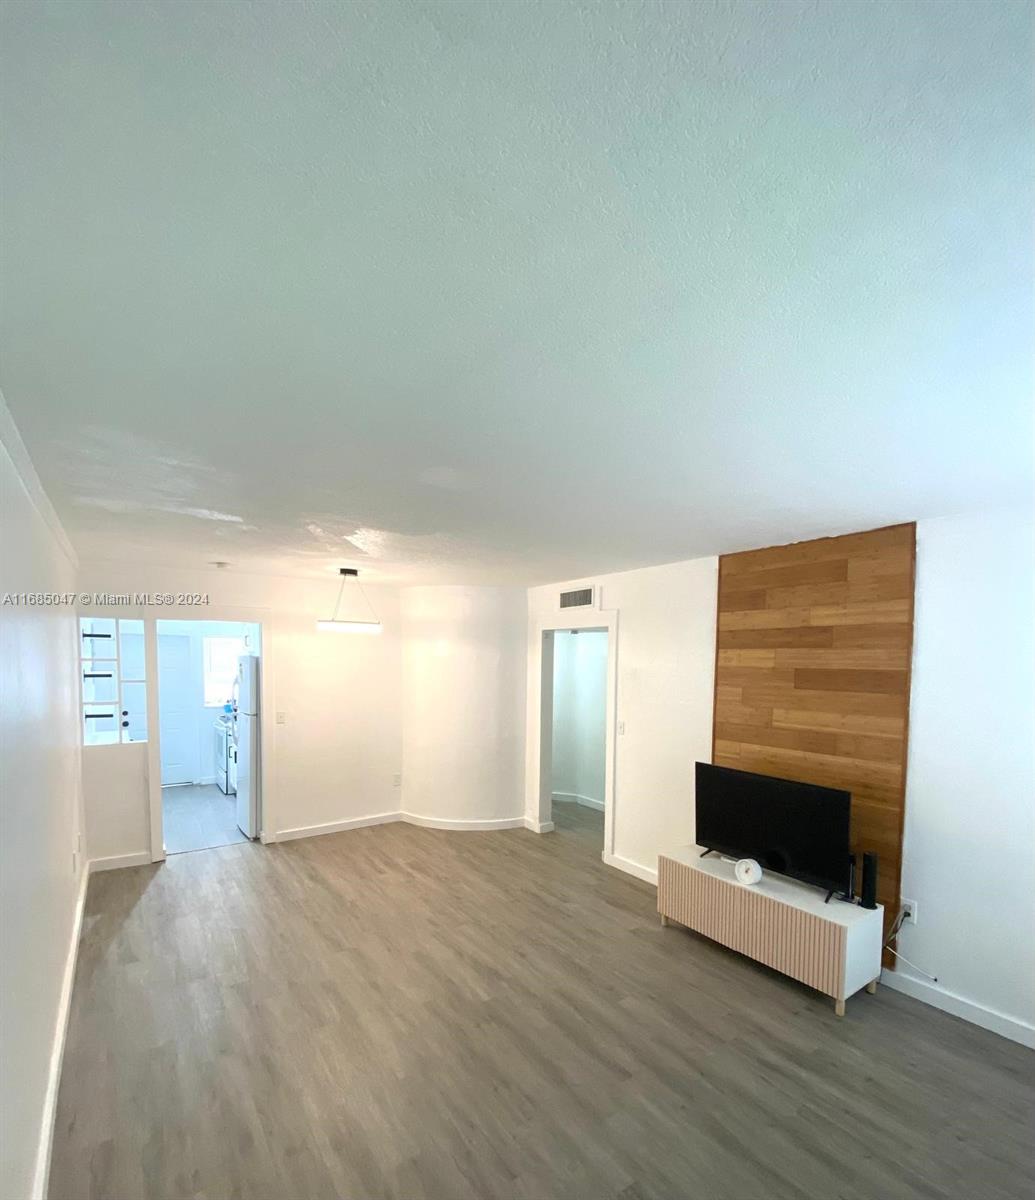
left=0, top=401, right=82, bottom=1200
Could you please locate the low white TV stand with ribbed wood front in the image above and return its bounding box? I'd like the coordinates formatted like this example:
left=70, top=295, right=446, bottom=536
left=658, top=846, right=884, bottom=1016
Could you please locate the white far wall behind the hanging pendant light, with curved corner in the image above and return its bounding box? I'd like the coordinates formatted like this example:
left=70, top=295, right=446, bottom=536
left=79, top=563, right=526, bottom=844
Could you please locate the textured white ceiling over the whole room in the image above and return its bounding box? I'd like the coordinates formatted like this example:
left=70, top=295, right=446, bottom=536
left=0, top=0, right=1031, bottom=582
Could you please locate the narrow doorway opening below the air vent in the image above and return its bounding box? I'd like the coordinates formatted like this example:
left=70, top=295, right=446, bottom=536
left=550, top=629, right=608, bottom=853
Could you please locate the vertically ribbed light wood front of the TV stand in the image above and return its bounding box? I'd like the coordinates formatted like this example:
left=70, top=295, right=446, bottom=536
left=658, top=856, right=845, bottom=1000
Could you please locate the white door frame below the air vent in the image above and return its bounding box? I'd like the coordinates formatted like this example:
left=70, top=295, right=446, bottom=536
left=525, top=608, right=618, bottom=865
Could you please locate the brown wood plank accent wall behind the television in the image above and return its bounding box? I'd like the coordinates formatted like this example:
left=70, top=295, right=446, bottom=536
left=712, top=524, right=916, bottom=965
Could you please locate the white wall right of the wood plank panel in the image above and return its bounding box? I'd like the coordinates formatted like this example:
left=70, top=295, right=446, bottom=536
left=895, top=511, right=1035, bottom=1045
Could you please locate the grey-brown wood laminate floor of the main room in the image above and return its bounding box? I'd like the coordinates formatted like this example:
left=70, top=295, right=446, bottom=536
left=49, top=805, right=1035, bottom=1200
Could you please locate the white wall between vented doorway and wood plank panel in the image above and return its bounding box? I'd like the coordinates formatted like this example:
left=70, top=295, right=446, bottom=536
left=525, top=558, right=718, bottom=877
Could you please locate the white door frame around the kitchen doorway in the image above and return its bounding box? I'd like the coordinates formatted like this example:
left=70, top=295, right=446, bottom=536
left=147, top=605, right=276, bottom=863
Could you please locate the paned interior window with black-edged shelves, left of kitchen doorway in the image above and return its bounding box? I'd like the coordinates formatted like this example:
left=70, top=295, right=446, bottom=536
left=79, top=617, right=148, bottom=746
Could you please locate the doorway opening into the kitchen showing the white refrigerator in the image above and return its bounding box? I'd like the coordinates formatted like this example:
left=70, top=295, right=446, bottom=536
left=157, top=620, right=262, bottom=854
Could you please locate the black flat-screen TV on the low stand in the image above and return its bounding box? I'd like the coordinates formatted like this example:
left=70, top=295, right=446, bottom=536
left=696, top=762, right=851, bottom=892
